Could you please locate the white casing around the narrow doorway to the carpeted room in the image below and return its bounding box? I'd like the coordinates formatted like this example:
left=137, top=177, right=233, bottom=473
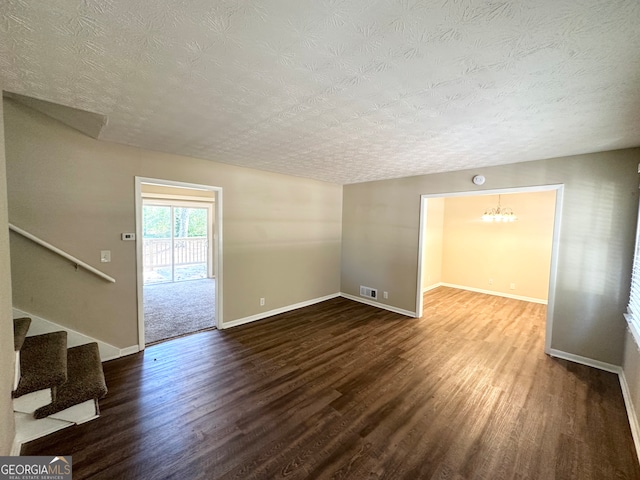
left=135, top=177, right=223, bottom=350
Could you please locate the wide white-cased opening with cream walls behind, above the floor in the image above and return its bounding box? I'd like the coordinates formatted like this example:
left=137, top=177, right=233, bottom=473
left=416, top=185, right=563, bottom=353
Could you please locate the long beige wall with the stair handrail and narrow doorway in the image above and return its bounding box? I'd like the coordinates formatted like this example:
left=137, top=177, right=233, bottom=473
left=5, top=100, right=342, bottom=348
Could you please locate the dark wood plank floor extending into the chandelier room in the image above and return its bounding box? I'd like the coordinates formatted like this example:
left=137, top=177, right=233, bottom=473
left=22, top=287, right=640, bottom=480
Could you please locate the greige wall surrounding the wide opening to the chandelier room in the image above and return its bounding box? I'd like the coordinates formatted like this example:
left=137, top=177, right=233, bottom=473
left=342, top=149, right=640, bottom=365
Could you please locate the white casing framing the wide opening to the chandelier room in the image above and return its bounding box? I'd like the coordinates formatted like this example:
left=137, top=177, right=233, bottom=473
left=416, top=184, right=564, bottom=354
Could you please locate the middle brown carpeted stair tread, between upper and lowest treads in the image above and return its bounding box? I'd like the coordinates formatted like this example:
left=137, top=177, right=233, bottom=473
left=13, top=332, right=67, bottom=398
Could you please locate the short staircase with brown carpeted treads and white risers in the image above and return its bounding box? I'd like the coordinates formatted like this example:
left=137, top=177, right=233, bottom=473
left=13, top=318, right=107, bottom=443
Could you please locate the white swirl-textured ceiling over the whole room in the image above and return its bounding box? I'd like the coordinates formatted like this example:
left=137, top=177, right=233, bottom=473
left=0, top=0, right=640, bottom=183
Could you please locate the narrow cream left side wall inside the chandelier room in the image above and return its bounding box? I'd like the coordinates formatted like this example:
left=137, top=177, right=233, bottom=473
left=422, top=198, right=445, bottom=288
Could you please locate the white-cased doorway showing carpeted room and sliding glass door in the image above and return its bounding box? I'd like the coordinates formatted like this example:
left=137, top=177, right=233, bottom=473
left=136, top=177, right=222, bottom=350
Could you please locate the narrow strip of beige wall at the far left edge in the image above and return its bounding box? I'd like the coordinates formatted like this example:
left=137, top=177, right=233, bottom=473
left=0, top=93, right=15, bottom=455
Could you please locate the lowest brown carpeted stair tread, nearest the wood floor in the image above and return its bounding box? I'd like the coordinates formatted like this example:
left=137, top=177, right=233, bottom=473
left=34, top=343, right=107, bottom=418
